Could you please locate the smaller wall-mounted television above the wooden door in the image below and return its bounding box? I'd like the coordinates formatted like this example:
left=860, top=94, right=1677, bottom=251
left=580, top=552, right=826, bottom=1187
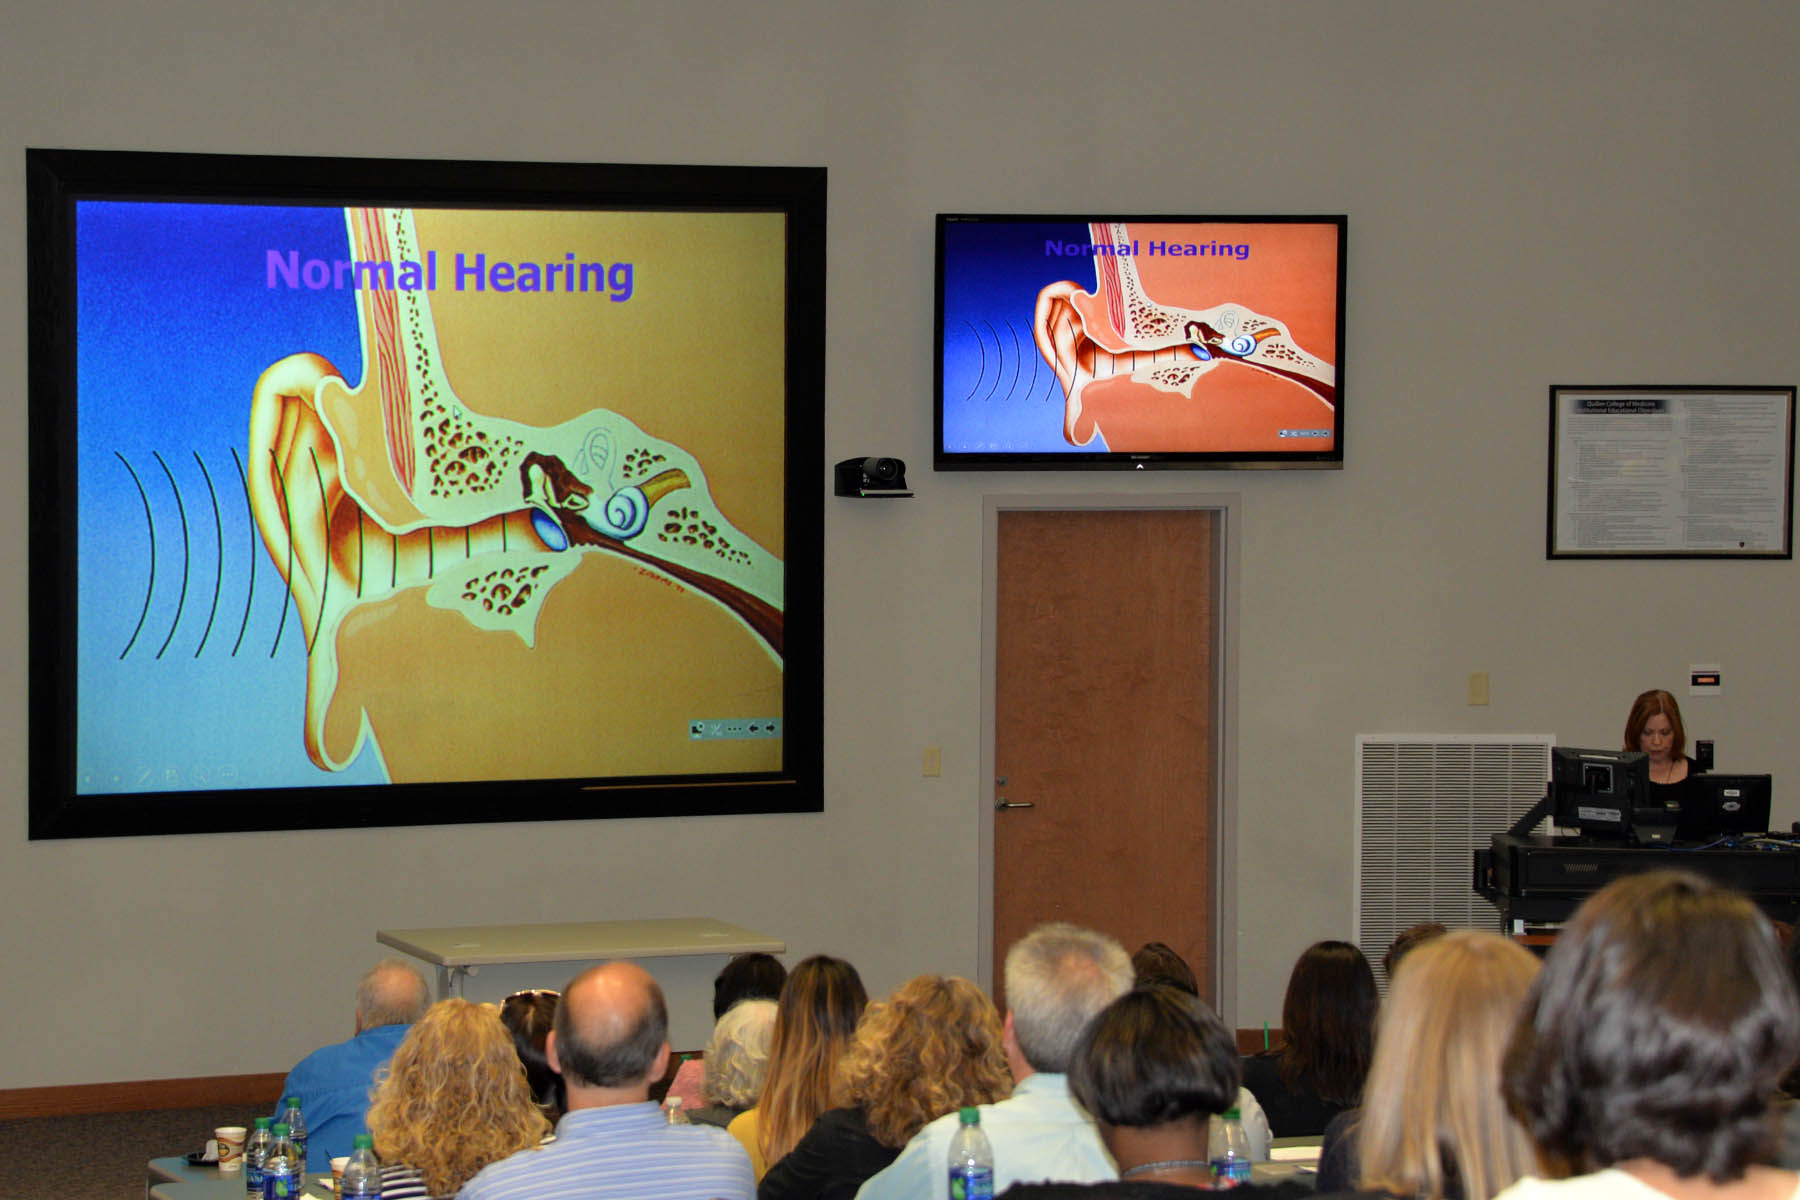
left=934, top=214, right=1346, bottom=470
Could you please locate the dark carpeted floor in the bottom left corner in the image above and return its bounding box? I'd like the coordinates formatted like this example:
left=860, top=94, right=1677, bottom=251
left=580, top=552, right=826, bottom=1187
left=0, top=1105, right=268, bottom=1200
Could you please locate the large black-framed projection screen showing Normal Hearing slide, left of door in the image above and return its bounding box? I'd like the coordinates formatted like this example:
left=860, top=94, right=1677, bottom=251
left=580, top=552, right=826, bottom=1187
left=27, top=149, right=826, bottom=838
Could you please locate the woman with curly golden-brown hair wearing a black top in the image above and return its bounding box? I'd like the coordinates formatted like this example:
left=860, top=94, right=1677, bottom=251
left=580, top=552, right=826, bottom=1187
left=756, top=975, right=1012, bottom=1200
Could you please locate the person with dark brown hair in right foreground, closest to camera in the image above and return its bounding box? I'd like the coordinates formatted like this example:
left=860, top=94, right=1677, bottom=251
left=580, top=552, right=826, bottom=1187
left=1501, top=871, right=1800, bottom=1200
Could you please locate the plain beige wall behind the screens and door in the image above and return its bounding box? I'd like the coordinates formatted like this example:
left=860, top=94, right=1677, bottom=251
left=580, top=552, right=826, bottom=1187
left=0, top=0, right=1800, bottom=1087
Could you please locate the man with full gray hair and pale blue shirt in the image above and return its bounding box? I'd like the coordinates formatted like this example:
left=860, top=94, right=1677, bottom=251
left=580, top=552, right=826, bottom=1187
left=857, top=923, right=1132, bottom=1200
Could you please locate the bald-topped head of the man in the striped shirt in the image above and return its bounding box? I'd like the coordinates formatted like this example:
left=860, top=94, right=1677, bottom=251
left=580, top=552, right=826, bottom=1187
left=556, top=963, right=670, bottom=1088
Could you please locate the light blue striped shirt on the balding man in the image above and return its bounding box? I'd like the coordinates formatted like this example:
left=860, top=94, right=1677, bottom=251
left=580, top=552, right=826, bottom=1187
left=457, top=1101, right=756, bottom=1200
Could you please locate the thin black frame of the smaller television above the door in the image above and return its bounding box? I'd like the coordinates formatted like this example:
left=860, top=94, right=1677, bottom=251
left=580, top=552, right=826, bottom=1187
left=932, top=212, right=1350, bottom=471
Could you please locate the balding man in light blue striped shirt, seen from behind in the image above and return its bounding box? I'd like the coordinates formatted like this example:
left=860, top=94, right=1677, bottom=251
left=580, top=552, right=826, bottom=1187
left=457, top=963, right=756, bottom=1200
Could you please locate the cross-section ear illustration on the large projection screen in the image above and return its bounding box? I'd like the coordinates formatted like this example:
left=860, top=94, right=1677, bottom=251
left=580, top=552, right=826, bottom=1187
left=245, top=209, right=783, bottom=770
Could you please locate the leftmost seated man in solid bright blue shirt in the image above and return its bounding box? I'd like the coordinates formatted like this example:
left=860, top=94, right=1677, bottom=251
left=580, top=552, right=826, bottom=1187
left=275, top=959, right=432, bottom=1171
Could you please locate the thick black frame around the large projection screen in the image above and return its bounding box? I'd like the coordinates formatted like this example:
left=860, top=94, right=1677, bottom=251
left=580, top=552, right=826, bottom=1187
left=25, top=148, right=826, bottom=840
